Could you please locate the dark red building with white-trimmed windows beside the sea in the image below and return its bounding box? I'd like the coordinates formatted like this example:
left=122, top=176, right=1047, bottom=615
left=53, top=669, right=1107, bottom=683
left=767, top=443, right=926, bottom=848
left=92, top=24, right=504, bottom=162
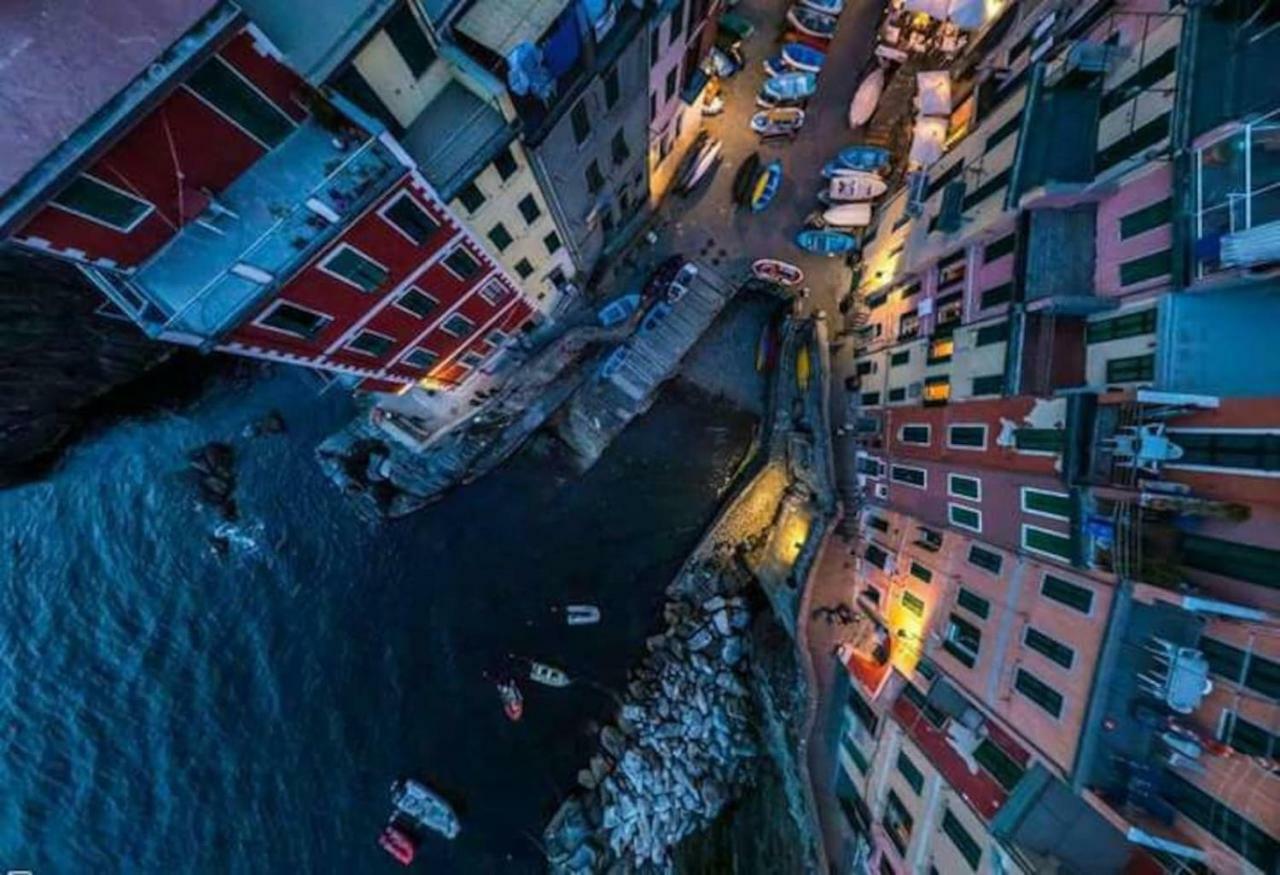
left=0, top=0, right=532, bottom=391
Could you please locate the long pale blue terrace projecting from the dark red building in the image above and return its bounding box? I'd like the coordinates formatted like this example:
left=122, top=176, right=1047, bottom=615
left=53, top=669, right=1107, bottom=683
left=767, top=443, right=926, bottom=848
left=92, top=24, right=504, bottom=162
left=120, top=119, right=404, bottom=343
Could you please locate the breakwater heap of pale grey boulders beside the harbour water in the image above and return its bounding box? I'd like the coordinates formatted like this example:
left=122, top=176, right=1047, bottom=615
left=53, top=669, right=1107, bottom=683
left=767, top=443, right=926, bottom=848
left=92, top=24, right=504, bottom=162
left=544, top=551, right=759, bottom=872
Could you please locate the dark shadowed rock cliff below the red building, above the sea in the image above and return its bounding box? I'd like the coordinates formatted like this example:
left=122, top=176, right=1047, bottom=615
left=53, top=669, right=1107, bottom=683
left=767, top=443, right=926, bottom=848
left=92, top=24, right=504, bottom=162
left=0, top=247, right=219, bottom=486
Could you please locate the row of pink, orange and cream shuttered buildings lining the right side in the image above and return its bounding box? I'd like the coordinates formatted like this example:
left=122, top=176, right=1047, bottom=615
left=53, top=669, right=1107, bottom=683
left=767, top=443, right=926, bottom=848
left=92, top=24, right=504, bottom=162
left=833, top=0, right=1280, bottom=875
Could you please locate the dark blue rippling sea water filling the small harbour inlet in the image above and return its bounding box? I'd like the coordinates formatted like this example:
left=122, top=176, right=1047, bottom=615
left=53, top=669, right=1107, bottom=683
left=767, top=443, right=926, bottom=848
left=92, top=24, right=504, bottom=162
left=0, top=372, right=751, bottom=875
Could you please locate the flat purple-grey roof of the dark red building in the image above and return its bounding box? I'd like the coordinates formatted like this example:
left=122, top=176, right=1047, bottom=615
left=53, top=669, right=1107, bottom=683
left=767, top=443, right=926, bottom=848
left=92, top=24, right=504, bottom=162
left=0, top=0, right=220, bottom=193
